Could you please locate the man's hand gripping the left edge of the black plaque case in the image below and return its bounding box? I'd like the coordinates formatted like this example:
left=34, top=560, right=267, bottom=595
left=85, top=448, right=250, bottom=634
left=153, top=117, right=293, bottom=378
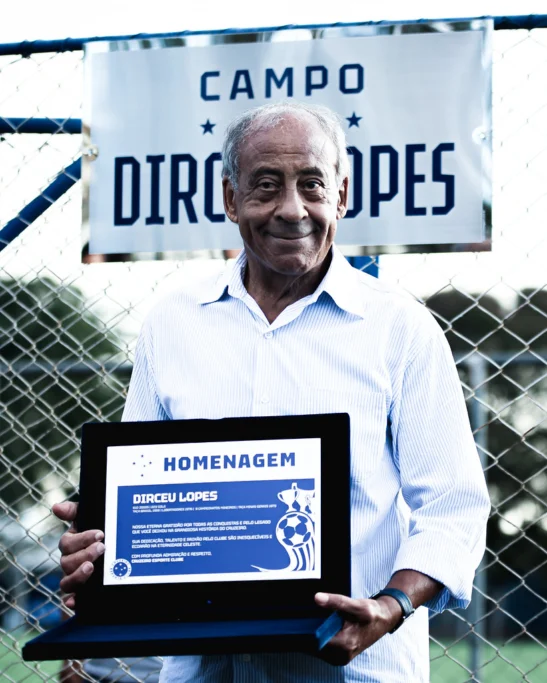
left=52, top=503, right=104, bottom=609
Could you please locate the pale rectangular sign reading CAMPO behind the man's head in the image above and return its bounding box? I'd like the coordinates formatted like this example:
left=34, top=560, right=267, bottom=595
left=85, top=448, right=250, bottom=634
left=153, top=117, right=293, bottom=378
left=83, top=22, right=490, bottom=254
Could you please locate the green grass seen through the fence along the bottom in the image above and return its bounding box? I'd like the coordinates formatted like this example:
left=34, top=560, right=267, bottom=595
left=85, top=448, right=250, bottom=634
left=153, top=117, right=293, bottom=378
left=0, top=634, right=547, bottom=683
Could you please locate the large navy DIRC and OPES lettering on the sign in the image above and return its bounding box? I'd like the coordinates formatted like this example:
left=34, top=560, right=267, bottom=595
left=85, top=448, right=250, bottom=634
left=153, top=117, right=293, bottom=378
left=113, top=142, right=456, bottom=226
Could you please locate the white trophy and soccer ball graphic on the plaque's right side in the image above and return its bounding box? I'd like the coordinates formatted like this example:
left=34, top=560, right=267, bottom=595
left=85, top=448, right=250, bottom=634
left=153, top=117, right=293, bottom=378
left=253, top=483, right=315, bottom=572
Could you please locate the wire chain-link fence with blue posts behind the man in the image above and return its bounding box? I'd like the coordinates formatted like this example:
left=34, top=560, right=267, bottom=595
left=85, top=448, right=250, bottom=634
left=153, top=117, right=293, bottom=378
left=0, top=18, right=547, bottom=683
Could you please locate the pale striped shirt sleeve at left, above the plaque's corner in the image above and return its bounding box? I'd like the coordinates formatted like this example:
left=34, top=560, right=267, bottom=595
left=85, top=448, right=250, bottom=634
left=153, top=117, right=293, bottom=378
left=122, top=322, right=169, bottom=422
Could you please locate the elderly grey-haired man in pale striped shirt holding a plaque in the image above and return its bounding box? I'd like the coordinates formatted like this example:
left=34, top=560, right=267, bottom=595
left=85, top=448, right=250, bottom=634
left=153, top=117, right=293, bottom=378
left=55, top=103, right=489, bottom=683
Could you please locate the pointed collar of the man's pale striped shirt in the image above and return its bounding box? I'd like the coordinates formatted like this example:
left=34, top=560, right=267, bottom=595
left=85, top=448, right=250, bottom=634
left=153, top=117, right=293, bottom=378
left=198, top=245, right=364, bottom=318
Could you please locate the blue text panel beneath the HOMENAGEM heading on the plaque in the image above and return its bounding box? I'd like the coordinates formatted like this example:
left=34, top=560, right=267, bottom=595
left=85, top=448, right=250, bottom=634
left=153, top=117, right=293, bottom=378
left=116, top=479, right=314, bottom=579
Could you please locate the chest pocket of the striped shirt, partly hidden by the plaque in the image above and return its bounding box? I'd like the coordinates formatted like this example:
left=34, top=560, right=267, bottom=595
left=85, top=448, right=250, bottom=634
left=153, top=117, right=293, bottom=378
left=295, top=387, right=389, bottom=483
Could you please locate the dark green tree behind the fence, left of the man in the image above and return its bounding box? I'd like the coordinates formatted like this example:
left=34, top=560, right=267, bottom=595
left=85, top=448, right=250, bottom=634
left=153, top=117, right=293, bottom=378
left=0, top=279, right=127, bottom=511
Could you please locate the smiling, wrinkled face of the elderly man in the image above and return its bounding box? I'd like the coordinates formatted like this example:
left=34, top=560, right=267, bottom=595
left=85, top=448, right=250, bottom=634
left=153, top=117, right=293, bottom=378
left=224, top=116, right=348, bottom=276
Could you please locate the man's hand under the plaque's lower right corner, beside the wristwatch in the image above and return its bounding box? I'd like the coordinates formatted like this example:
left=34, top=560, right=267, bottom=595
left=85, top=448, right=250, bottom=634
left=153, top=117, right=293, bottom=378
left=315, top=593, right=403, bottom=666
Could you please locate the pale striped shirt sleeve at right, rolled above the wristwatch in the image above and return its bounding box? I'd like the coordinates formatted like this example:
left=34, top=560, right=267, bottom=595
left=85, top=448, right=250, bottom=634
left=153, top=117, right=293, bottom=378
left=391, top=311, right=490, bottom=612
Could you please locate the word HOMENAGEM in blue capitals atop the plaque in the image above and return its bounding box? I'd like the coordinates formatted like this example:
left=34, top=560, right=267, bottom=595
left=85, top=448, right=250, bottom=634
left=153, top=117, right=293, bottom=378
left=163, top=453, right=296, bottom=472
